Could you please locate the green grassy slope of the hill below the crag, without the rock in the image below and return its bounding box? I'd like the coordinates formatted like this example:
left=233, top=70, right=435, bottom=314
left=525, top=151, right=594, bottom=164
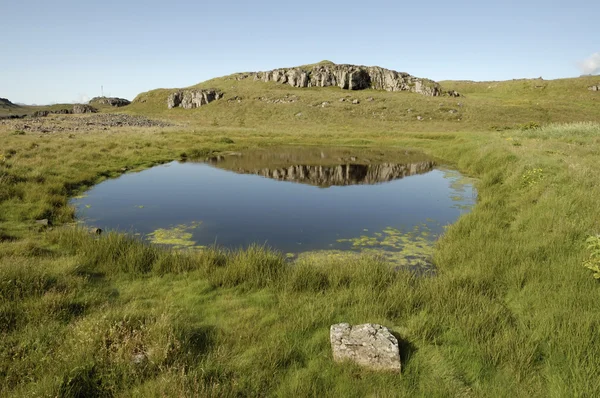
left=127, top=67, right=600, bottom=131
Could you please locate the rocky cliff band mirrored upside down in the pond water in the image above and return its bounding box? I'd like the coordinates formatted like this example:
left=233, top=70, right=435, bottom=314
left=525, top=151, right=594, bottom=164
left=212, top=158, right=435, bottom=187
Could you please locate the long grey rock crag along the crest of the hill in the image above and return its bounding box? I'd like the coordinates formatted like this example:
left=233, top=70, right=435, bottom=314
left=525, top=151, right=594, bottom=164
left=235, top=63, right=459, bottom=96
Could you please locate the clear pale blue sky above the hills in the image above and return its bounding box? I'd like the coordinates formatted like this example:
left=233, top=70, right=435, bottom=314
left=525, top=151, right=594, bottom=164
left=0, top=0, right=600, bottom=104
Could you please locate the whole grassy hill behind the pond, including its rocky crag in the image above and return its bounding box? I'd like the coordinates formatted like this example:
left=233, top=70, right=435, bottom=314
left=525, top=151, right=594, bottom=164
left=129, top=62, right=600, bottom=131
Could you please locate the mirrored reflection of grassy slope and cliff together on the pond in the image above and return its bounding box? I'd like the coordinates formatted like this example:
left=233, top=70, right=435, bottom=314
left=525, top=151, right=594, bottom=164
left=207, top=149, right=435, bottom=187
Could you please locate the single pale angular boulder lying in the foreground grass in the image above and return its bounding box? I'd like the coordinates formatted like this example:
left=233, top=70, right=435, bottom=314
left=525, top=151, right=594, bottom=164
left=329, top=323, right=401, bottom=372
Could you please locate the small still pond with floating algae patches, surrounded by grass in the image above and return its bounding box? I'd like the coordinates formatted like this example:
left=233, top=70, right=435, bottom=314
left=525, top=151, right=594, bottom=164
left=71, top=148, right=476, bottom=268
